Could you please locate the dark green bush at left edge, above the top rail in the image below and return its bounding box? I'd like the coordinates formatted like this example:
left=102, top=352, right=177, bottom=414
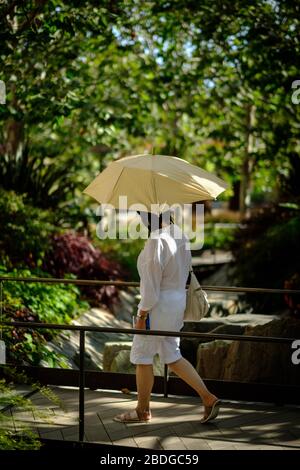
left=0, top=188, right=57, bottom=267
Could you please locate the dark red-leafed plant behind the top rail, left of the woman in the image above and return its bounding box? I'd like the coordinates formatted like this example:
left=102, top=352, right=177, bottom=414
left=43, top=232, right=127, bottom=308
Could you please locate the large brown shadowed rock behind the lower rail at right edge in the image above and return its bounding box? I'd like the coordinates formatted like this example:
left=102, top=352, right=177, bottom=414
left=197, top=317, right=300, bottom=385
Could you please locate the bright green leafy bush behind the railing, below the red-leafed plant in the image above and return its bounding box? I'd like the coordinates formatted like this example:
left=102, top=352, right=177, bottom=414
left=0, top=267, right=88, bottom=367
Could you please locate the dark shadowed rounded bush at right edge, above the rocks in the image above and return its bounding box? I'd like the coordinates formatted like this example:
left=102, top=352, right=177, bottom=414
left=232, top=206, right=300, bottom=312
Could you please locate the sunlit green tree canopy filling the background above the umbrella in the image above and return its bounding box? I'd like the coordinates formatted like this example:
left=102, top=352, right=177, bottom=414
left=0, top=0, right=300, bottom=208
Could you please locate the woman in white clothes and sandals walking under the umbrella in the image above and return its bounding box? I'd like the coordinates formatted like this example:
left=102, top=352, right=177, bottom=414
left=114, top=212, right=220, bottom=423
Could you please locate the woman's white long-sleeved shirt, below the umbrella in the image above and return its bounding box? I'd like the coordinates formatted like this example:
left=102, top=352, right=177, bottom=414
left=137, top=224, right=192, bottom=310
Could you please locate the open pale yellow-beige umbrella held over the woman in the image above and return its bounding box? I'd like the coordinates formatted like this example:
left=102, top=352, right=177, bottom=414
left=83, top=154, right=228, bottom=210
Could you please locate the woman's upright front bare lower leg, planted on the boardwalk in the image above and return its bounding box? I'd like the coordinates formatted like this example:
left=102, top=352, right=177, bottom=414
left=136, top=364, right=154, bottom=414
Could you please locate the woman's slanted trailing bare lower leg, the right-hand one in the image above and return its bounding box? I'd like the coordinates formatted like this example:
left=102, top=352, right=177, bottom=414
left=168, top=357, right=217, bottom=406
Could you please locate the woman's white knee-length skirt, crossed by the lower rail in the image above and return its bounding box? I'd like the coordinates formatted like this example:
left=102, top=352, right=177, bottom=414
left=130, top=289, right=186, bottom=364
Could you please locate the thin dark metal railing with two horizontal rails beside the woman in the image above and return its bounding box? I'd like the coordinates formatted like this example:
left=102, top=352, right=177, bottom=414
left=0, top=276, right=300, bottom=442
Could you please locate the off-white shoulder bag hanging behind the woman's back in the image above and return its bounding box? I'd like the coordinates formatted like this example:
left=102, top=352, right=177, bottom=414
left=183, top=266, right=210, bottom=322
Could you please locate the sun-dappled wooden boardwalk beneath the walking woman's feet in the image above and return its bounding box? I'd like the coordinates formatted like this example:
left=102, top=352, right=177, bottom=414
left=6, top=387, right=300, bottom=450
